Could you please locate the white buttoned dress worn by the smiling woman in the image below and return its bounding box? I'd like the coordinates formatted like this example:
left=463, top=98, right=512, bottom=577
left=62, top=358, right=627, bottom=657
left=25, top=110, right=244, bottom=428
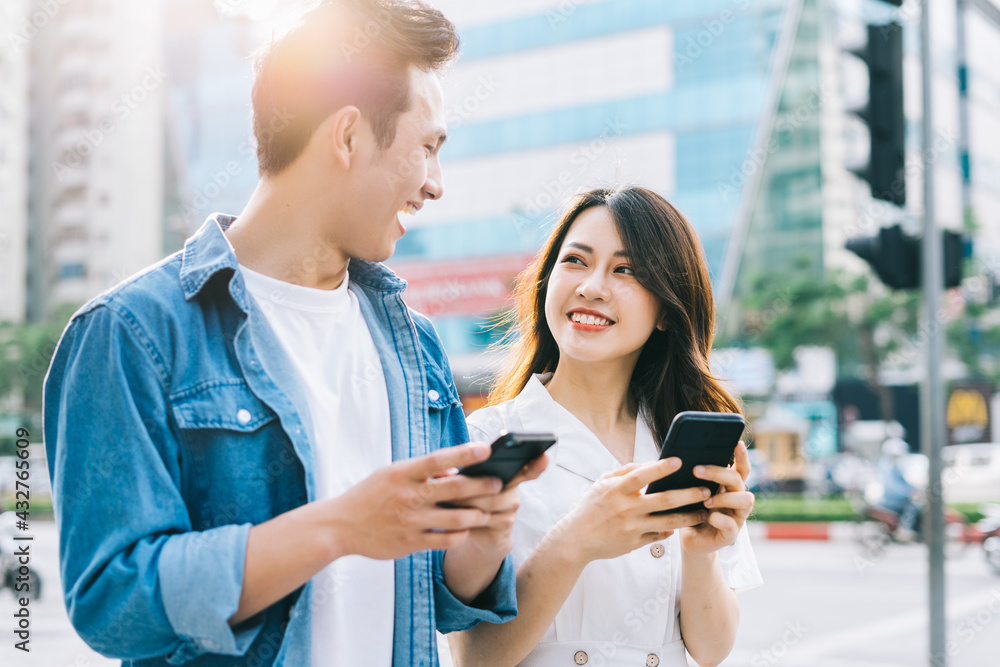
left=468, top=374, right=763, bottom=667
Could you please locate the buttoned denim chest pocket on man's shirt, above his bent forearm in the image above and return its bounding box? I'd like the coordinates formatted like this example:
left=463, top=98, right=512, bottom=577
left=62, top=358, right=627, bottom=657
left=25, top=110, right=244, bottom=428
left=171, top=378, right=304, bottom=530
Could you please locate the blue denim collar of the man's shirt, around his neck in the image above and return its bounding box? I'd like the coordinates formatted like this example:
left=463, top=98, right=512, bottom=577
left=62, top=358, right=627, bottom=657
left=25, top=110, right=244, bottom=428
left=180, top=213, right=406, bottom=304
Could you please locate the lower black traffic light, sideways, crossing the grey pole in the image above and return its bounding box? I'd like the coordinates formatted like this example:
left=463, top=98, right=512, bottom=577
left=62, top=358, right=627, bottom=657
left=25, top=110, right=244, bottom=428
left=847, top=225, right=966, bottom=289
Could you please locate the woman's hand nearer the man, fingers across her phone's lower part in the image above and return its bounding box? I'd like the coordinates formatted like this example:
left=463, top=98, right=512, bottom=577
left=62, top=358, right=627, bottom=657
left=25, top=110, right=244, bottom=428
left=539, top=458, right=707, bottom=564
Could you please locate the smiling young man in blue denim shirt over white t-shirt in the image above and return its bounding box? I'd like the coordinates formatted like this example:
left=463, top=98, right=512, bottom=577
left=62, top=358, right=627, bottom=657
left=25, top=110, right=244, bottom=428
left=45, top=0, right=544, bottom=667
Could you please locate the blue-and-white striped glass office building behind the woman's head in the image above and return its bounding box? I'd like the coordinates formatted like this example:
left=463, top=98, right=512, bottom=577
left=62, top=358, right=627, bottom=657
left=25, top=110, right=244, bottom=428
left=391, top=0, right=823, bottom=392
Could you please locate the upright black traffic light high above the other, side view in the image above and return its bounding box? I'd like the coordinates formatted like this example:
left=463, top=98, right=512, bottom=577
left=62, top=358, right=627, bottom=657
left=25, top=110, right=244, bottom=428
left=851, top=19, right=906, bottom=206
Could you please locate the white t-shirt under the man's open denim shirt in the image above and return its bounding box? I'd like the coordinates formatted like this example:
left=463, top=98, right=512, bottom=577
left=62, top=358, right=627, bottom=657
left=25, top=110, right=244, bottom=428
left=240, top=265, right=395, bottom=667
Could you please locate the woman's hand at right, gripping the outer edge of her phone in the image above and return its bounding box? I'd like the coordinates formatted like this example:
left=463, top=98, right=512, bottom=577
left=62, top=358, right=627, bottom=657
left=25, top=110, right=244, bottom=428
left=681, top=440, right=754, bottom=554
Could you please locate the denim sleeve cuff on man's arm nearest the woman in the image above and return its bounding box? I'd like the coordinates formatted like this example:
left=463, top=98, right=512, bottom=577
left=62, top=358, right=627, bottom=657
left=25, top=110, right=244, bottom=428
left=434, top=551, right=517, bottom=634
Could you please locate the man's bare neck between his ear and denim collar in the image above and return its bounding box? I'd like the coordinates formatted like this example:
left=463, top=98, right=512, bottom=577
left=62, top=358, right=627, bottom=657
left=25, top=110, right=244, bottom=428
left=226, top=179, right=350, bottom=290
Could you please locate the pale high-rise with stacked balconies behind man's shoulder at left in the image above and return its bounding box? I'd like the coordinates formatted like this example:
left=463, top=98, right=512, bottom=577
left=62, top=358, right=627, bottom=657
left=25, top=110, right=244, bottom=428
left=28, top=0, right=170, bottom=319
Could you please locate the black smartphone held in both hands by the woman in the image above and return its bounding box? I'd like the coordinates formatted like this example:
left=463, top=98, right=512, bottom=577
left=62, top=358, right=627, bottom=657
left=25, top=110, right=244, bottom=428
left=646, top=411, right=746, bottom=514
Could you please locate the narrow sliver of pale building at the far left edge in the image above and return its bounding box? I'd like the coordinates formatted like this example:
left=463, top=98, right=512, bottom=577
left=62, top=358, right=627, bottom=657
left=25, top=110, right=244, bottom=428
left=0, top=0, right=29, bottom=322
